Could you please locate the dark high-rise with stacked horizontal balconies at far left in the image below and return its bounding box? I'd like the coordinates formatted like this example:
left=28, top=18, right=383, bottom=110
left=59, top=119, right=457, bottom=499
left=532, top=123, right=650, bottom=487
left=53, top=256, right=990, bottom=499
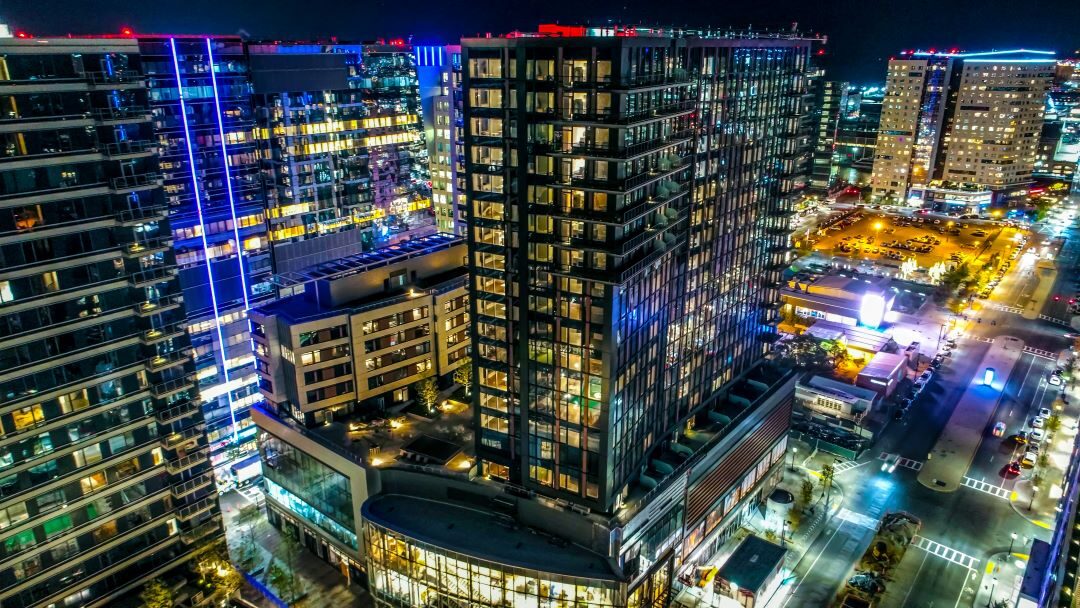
left=0, top=39, right=222, bottom=608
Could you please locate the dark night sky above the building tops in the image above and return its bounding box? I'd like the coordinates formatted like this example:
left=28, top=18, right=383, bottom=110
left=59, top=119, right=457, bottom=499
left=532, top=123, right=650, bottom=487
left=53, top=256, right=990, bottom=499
left=6, top=0, right=1080, bottom=82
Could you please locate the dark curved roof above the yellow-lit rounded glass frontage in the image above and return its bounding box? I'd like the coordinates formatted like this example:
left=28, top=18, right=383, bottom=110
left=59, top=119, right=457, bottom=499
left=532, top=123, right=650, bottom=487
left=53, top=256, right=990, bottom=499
left=362, top=494, right=620, bottom=581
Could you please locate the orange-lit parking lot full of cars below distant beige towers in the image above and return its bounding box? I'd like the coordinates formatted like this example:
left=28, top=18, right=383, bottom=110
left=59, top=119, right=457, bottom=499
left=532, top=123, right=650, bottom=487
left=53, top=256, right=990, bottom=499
left=813, top=210, right=1022, bottom=269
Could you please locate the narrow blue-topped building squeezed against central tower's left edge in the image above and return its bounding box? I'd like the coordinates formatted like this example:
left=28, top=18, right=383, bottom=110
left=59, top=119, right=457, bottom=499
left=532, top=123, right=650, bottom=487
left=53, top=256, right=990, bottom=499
left=413, top=44, right=465, bottom=237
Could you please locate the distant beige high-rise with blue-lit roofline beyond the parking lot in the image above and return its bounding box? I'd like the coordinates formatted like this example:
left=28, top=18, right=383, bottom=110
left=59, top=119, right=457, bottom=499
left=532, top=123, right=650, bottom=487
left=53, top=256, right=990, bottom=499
left=870, top=50, right=1054, bottom=208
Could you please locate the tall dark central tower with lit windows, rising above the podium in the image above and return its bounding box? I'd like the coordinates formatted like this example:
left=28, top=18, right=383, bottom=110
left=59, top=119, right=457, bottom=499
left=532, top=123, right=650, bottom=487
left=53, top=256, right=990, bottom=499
left=462, top=37, right=812, bottom=511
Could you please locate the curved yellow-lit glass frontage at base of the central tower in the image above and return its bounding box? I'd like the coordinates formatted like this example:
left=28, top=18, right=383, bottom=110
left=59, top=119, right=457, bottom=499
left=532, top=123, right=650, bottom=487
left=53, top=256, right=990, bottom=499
left=364, top=521, right=625, bottom=608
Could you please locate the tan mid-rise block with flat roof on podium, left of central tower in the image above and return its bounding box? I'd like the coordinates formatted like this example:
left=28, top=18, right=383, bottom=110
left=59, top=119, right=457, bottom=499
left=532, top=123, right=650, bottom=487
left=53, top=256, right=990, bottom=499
left=251, top=234, right=469, bottom=423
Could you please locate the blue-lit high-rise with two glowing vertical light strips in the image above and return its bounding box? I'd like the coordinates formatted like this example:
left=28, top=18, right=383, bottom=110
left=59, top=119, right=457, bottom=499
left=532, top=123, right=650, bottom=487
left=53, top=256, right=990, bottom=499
left=138, top=37, right=274, bottom=481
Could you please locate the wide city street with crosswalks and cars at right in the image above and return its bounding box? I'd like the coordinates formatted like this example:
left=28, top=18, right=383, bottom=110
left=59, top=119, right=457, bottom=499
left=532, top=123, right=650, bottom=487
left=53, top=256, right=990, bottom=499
left=785, top=208, right=1078, bottom=608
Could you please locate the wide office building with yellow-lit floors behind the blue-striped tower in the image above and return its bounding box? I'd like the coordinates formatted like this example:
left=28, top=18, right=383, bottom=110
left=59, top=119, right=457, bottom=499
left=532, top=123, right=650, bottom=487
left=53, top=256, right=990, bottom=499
left=248, top=40, right=435, bottom=278
